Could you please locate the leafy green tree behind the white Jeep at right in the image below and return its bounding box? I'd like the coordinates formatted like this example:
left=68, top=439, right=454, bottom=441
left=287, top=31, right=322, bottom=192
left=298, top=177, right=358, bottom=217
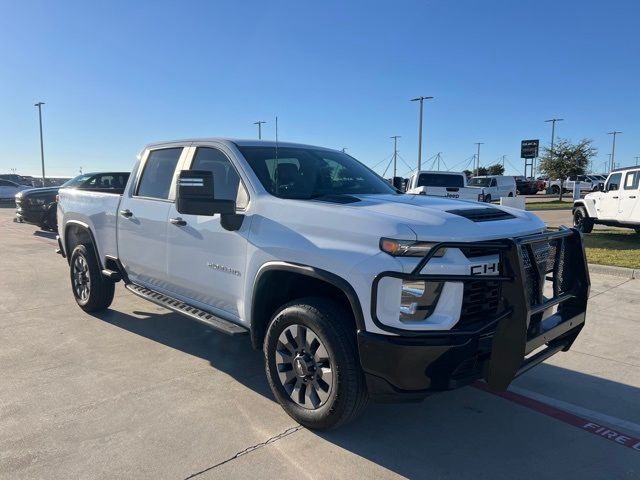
left=540, top=138, right=598, bottom=200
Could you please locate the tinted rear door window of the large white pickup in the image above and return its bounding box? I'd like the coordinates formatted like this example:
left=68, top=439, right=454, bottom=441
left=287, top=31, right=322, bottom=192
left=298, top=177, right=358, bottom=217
left=136, top=147, right=182, bottom=200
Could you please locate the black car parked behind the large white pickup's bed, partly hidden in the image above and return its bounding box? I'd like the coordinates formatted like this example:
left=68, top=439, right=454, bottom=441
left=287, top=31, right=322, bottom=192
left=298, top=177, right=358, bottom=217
left=16, top=172, right=129, bottom=230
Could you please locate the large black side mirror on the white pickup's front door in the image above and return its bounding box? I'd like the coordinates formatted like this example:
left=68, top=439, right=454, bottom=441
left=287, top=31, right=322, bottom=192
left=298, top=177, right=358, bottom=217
left=176, top=170, right=236, bottom=216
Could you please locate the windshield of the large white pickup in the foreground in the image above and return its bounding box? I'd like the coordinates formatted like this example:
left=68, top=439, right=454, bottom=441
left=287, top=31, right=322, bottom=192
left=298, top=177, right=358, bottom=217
left=239, top=147, right=396, bottom=199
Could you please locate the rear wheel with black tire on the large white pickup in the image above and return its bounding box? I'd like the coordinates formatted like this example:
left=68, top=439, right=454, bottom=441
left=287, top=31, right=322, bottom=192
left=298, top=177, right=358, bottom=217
left=69, top=244, right=115, bottom=312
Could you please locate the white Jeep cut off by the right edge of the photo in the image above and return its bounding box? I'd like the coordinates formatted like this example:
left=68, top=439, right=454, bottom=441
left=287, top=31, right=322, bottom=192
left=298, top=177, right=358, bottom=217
left=573, top=167, right=640, bottom=233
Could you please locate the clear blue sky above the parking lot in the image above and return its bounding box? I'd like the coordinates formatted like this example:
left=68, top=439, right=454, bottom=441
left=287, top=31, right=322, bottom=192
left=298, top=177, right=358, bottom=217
left=0, top=0, right=640, bottom=175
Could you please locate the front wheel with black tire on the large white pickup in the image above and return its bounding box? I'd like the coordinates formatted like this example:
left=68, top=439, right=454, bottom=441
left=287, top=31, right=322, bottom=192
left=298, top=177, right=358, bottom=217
left=263, top=297, right=368, bottom=430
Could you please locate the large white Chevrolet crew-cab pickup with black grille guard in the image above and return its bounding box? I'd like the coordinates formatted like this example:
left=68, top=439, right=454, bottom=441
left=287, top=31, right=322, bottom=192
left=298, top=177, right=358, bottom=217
left=58, top=139, right=589, bottom=429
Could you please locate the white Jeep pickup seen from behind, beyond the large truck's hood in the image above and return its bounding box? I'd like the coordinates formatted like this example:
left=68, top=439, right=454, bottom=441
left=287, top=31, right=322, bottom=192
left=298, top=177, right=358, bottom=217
left=407, top=170, right=485, bottom=202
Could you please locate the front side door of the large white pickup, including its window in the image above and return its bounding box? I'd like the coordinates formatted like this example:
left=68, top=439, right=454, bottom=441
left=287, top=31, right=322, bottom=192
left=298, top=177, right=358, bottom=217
left=167, top=144, right=249, bottom=319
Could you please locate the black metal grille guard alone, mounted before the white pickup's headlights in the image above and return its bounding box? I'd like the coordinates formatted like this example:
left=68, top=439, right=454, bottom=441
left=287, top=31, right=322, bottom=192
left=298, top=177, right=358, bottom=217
left=371, top=227, right=590, bottom=390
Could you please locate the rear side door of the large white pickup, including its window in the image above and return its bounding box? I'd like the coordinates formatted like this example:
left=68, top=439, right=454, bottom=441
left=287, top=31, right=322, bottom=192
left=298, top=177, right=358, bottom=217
left=118, top=145, right=186, bottom=290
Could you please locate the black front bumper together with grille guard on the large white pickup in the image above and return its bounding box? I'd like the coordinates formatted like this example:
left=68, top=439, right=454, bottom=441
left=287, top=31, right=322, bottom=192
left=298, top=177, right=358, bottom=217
left=358, top=228, right=590, bottom=401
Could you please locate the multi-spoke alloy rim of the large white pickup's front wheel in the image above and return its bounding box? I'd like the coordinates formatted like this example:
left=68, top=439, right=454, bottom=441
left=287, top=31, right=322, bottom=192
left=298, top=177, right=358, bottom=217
left=275, top=324, right=334, bottom=410
